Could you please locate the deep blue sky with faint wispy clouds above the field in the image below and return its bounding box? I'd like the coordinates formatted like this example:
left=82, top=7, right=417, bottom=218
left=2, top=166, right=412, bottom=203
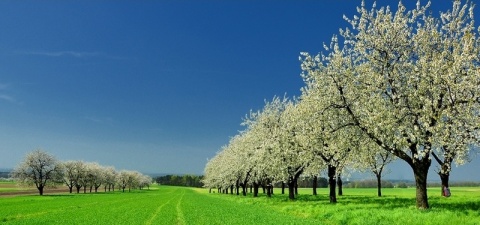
left=0, top=0, right=480, bottom=180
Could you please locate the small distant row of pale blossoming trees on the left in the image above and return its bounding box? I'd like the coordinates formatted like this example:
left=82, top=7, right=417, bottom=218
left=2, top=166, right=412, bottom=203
left=11, top=149, right=152, bottom=195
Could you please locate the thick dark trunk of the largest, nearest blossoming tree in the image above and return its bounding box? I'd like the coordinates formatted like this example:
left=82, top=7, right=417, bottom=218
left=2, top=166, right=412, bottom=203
left=411, top=158, right=431, bottom=209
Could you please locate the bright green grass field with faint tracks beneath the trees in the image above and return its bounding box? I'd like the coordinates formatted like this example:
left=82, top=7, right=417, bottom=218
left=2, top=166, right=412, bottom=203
left=0, top=184, right=480, bottom=225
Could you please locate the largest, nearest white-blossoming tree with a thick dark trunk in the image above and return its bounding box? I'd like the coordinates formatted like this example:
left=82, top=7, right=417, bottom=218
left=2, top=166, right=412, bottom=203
left=302, top=1, right=480, bottom=209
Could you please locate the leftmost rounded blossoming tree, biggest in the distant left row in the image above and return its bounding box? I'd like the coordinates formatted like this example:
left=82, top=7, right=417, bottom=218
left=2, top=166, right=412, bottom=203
left=12, top=149, right=63, bottom=195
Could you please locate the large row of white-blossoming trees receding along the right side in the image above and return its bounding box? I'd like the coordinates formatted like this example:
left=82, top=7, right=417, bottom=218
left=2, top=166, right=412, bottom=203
left=204, top=0, right=480, bottom=209
